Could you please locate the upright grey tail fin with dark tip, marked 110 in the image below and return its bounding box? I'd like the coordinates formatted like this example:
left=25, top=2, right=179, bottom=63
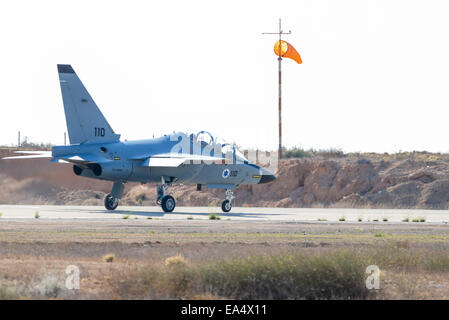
left=58, top=64, right=120, bottom=144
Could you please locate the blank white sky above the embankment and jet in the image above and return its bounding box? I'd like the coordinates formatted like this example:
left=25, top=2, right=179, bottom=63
left=0, top=0, right=449, bottom=152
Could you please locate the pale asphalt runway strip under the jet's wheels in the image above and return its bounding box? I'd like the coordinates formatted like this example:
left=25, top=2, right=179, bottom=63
left=0, top=205, right=449, bottom=224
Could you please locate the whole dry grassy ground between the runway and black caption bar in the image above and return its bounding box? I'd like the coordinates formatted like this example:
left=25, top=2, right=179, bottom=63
left=0, top=219, right=449, bottom=299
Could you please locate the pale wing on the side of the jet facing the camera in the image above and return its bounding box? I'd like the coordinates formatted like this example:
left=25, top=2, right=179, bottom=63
left=141, top=153, right=229, bottom=167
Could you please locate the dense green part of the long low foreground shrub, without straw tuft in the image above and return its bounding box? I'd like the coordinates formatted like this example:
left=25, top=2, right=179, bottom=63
left=200, top=252, right=368, bottom=299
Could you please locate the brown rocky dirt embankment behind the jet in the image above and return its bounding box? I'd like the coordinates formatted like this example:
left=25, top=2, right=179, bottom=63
left=0, top=151, right=449, bottom=209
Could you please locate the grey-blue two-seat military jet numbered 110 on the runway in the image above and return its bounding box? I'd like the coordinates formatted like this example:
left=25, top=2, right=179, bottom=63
left=4, top=64, right=275, bottom=212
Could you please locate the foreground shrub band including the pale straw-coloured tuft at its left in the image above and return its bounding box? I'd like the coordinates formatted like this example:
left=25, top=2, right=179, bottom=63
left=118, top=251, right=369, bottom=299
